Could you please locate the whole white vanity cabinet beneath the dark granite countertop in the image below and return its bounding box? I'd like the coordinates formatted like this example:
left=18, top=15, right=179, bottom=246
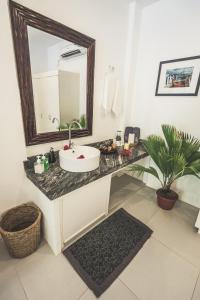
left=27, top=152, right=148, bottom=255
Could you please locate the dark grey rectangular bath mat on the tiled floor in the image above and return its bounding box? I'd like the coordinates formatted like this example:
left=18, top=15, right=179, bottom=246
left=63, top=209, right=152, bottom=297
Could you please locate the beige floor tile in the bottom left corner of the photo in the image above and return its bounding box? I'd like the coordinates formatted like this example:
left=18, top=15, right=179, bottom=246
left=0, top=269, right=27, bottom=300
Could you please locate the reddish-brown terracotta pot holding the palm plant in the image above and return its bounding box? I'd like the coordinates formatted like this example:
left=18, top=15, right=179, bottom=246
left=156, top=189, right=178, bottom=210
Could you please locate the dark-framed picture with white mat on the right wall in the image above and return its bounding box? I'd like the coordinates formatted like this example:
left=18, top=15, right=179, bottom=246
left=156, top=56, right=200, bottom=96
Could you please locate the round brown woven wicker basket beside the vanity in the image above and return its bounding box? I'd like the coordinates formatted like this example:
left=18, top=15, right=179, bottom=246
left=0, top=203, right=42, bottom=258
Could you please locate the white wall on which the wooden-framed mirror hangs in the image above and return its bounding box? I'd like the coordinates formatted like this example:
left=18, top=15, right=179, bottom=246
left=0, top=0, right=129, bottom=212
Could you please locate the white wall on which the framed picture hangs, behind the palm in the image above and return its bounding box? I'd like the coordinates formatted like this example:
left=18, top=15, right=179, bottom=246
left=126, top=0, right=200, bottom=207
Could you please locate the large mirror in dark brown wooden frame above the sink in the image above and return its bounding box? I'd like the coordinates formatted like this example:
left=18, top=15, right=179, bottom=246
left=9, top=1, right=95, bottom=146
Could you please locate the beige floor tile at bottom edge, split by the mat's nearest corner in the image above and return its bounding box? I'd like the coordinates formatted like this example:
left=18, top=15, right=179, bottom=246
left=80, top=279, right=139, bottom=300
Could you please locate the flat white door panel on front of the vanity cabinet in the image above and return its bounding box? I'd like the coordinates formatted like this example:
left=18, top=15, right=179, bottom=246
left=62, top=175, right=111, bottom=243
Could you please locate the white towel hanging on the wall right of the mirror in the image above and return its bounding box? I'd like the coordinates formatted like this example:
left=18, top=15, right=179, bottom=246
left=102, top=72, right=120, bottom=116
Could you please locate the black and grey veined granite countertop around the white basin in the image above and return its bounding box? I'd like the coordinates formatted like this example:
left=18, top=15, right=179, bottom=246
left=24, top=140, right=148, bottom=200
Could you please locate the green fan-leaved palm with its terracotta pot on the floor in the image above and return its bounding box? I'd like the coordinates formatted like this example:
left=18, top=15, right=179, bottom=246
left=130, top=125, right=200, bottom=209
